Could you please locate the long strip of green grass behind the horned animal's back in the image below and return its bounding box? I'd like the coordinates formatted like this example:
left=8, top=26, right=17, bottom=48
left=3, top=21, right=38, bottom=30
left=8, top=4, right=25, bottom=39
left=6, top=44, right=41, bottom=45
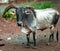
left=20, top=1, right=53, bottom=9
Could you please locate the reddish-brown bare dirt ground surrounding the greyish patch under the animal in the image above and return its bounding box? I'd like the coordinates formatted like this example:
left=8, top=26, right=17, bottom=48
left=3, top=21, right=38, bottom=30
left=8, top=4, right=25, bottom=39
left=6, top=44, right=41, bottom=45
left=0, top=6, right=60, bottom=51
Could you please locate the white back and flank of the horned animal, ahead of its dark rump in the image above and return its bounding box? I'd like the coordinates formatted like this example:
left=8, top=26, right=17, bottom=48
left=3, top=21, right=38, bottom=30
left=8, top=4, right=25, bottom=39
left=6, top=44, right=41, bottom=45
left=35, top=8, right=57, bottom=29
